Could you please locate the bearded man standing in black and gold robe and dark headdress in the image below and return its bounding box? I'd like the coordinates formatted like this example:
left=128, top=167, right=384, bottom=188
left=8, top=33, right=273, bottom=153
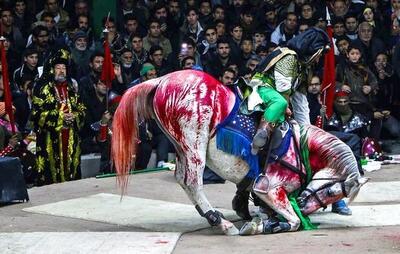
left=32, top=49, right=85, bottom=185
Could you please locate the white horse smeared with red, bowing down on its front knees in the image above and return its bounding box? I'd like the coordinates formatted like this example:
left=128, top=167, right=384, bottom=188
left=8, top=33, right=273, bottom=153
left=112, top=70, right=365, bottom=235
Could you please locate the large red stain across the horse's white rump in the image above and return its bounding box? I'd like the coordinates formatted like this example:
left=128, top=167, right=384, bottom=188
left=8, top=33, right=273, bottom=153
left=153, top=71, right=235, bottom=141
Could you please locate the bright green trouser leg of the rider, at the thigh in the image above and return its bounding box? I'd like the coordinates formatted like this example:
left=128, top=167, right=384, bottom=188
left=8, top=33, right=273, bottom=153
left=258, top=86, right=288, bottom=123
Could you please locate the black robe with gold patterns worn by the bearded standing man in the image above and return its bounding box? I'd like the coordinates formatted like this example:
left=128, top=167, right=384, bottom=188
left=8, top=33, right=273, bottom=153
left=32, top=79, right=85, bottom=185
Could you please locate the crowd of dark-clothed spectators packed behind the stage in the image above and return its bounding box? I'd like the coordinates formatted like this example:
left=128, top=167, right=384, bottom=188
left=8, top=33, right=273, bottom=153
left=0, top=0, right=400, bottom=187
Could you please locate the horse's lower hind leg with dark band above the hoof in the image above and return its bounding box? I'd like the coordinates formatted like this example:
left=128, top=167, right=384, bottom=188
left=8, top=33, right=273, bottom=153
left=175, top=157, right=239, bottom=235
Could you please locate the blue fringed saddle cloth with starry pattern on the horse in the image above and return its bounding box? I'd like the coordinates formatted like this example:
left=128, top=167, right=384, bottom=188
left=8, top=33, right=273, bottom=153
left=216, top=94, right=291, bottom=179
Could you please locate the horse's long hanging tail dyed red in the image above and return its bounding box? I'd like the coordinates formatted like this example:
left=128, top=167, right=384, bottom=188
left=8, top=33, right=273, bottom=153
left=111, top=83, right=155, bottom=193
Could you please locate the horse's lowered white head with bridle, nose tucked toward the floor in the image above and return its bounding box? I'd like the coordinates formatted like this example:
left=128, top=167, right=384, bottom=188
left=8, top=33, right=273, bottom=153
left=297, top=170, right=369, bottom=214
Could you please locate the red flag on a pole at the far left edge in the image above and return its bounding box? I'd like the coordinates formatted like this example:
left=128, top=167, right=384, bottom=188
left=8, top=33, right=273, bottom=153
left=0, top=38, right=15, bottom=134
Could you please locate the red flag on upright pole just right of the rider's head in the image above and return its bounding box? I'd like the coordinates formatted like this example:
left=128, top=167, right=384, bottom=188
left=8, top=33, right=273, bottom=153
left=321, top=25, right=336, bottom=118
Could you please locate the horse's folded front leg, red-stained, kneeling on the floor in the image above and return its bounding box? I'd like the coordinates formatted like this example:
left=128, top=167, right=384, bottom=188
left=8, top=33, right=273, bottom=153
left=240, top=185, right=300, bottom=235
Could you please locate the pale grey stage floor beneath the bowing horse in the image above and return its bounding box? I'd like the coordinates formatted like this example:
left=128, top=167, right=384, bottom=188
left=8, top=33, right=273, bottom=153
left=0, top=165, right=400, bottom=254
